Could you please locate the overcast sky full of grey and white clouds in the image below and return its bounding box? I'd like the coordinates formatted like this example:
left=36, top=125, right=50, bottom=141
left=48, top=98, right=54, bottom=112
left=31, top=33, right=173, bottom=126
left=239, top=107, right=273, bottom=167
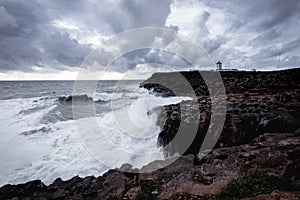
left=0, top=0, right=300, bottom=80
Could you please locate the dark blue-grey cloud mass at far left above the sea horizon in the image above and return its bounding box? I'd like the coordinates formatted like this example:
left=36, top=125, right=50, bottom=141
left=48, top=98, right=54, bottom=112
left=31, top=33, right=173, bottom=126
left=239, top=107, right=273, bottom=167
left=0, top=1, right=89, bottom=71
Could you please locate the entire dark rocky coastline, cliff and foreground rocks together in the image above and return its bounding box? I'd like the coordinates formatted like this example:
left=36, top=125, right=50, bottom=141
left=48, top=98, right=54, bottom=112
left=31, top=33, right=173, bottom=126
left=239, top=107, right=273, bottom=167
left=0, top=69, right=300, bottom=200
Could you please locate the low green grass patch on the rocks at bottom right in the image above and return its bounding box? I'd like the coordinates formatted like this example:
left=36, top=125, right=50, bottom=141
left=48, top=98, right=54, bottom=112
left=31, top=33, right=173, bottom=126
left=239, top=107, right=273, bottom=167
left=218, top=173, right=292, bottom=199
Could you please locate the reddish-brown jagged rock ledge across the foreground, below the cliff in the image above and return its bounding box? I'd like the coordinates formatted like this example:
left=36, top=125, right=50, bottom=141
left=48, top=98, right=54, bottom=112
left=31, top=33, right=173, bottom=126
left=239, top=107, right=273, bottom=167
left=0, top=133, right=300, bottom=199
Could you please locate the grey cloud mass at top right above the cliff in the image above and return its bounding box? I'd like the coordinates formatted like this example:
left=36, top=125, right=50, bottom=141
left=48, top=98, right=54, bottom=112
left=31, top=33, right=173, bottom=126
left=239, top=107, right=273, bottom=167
left=199, top=0, right=300, bottom=69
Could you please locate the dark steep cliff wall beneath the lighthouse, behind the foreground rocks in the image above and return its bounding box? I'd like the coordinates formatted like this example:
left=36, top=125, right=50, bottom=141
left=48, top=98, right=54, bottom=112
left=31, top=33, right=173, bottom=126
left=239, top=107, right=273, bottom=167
left=141, top=69, right=300, bottom=155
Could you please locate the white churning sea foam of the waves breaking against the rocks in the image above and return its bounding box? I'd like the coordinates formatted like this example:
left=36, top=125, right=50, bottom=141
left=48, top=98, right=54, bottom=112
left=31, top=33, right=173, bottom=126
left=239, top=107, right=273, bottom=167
left=0, top=89, right=188, bottom=185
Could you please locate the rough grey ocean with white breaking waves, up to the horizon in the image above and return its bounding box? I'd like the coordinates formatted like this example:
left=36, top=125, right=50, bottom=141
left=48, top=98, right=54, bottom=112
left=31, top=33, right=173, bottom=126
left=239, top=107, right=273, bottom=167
left=0, top=81, right=190, bottom=186
